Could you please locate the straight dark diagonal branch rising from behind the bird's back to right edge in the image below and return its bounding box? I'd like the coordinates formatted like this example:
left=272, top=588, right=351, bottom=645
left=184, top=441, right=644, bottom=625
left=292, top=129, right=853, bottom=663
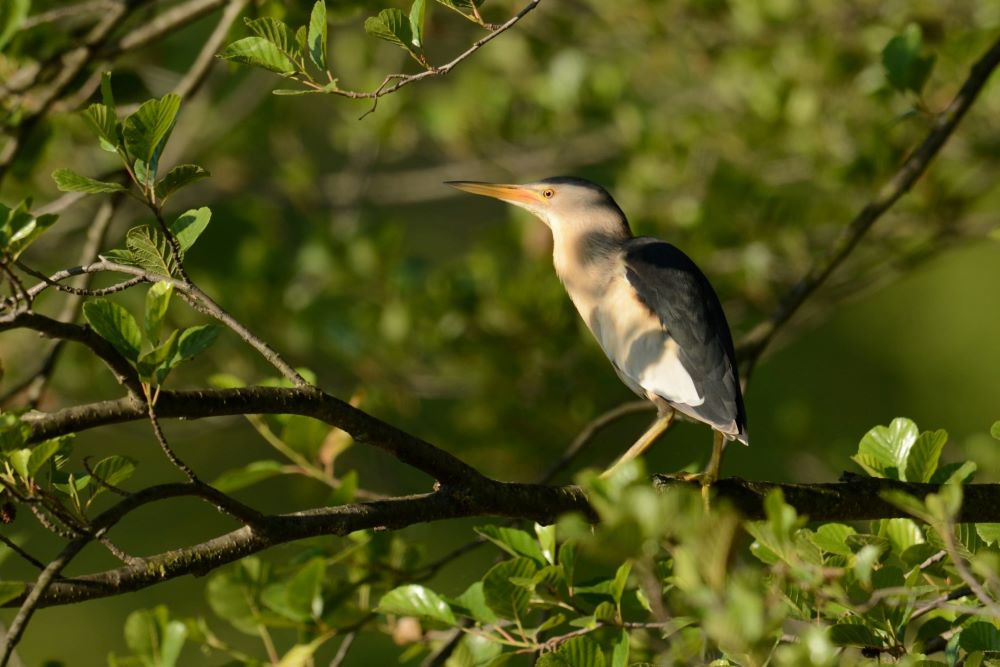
left=740, top=39, right=1000, bottom=377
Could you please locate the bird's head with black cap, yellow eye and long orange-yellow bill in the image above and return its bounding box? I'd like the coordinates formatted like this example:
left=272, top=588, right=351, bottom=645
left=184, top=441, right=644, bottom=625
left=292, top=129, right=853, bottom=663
left=448, top=176, right=631, bottom=236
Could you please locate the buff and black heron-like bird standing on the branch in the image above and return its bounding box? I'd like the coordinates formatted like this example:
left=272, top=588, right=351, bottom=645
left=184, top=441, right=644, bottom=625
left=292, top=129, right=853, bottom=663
left=447, top=176, right=750, bottom=486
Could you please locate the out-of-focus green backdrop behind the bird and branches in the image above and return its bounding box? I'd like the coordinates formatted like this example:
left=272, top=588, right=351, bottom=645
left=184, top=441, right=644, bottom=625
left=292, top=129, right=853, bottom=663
left=0, top=0, right=1000, bottom=665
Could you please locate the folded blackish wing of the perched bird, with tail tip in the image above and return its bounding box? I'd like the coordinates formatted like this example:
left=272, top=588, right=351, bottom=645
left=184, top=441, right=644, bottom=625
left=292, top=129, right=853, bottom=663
left=625, top=237, right=747, bottom=442
